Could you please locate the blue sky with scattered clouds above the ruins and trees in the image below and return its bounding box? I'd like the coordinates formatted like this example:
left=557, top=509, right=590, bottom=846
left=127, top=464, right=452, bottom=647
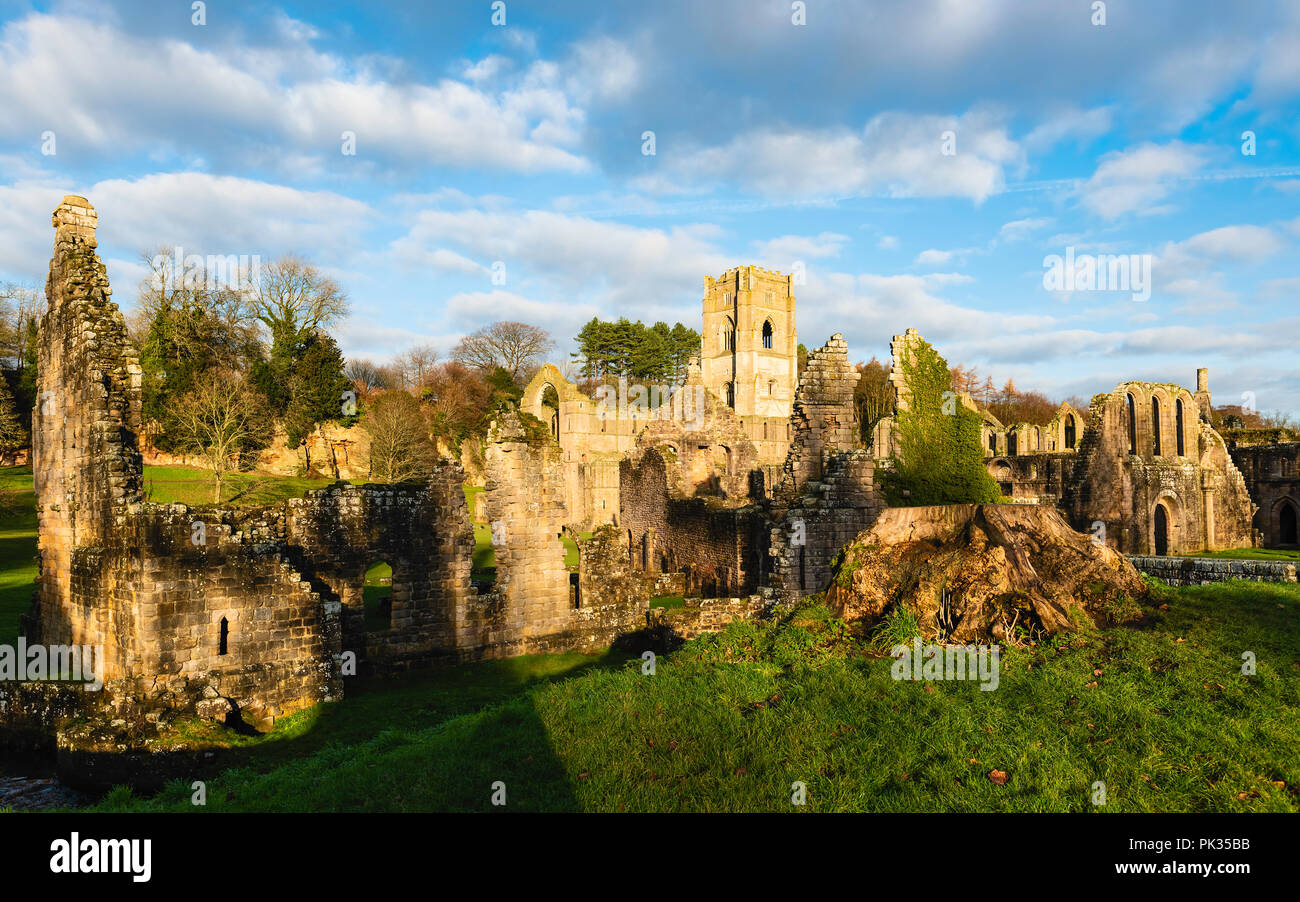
left=0, top=0, right=1300, bottom=415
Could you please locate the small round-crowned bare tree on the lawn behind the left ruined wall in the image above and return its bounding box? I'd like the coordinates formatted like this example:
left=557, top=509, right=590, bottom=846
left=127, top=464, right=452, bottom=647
left=172, top=370, right=270, bottom=504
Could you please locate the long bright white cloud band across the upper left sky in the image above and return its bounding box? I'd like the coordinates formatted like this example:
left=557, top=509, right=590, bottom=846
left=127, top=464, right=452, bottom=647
left=0, top=14, right=590, bottom=172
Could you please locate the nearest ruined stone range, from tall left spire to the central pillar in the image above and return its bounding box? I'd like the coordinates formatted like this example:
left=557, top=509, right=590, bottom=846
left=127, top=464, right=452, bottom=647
left=23, top=196, right=649, bottom=743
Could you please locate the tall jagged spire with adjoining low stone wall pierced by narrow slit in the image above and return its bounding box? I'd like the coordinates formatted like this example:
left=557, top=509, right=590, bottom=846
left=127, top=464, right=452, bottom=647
left=23, top=195, right=339, bottom=720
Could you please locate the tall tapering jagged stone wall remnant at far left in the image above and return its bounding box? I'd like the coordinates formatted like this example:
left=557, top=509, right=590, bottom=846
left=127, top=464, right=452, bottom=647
left=25, top=195, right=142, bottom=677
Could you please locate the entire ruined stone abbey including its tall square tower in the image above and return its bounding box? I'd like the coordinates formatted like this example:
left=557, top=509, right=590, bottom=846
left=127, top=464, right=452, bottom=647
left=10, top=196, right=1300, bottom=743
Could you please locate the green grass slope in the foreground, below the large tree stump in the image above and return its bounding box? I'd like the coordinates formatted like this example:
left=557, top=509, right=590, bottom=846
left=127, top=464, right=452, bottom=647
left=83, top=582, right=1300, bottom=811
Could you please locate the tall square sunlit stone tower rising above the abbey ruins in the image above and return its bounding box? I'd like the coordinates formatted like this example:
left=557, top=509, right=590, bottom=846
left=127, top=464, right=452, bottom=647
left=699, top=266, right=798, bottom=421
